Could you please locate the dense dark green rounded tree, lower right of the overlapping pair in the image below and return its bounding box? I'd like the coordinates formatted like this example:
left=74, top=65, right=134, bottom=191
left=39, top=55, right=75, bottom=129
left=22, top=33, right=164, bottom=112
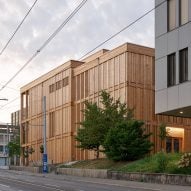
left=104, top=119, right=153, bottom=161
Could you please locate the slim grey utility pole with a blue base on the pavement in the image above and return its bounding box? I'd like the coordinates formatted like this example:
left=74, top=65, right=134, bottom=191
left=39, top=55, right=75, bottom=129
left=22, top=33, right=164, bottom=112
left=42, top=96, right=48, bottom=173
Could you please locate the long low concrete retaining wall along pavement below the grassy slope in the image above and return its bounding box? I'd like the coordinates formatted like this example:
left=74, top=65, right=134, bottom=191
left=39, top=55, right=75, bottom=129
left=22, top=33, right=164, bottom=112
left=56, top=168, right=191, bottom=185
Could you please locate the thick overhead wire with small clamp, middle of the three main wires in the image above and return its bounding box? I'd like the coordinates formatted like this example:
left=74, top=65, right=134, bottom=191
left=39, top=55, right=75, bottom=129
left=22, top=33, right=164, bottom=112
left=0, top=0, right=88, bottom=91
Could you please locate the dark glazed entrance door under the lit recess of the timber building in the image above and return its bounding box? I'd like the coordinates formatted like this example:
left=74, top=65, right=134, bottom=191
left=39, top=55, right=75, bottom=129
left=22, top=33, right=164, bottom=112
left=166, top=137, right=182, bottom=153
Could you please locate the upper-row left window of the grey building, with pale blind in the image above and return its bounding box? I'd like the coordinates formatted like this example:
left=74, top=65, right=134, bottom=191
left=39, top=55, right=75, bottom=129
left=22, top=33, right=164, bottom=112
left=167, top=0, right=176, bottom=31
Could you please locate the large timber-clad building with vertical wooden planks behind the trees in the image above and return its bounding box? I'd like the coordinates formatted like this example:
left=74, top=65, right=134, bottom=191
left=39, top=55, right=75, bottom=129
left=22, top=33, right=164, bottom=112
left=21, top=43, right=191, bottom=163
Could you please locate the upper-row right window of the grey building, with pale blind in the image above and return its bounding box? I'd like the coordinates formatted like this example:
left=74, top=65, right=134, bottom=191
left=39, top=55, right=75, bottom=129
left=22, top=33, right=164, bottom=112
left=179, top=0, right=188, bottom=25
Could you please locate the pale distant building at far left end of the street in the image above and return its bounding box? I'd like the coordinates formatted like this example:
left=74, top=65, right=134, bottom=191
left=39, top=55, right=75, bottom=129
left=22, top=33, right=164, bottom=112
left=0, top=124, right=13, bottom=168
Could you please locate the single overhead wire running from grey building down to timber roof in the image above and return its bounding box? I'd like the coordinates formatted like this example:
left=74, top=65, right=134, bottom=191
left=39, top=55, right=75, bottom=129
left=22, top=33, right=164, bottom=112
left=79, top=0, right=166, bottom=60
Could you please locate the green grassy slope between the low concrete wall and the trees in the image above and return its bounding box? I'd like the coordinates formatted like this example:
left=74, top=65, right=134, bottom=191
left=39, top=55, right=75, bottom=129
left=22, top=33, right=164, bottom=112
left=60, top=153, right=191, bottom=175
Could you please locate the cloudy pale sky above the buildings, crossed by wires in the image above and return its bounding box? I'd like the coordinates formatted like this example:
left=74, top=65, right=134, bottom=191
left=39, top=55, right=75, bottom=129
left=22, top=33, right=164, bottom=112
left=0, top=0, right=154, bottom=123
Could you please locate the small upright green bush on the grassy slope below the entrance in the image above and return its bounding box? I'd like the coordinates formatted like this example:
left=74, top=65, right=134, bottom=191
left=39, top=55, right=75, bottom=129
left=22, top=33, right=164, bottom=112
left=156, top=152, right=169, bottom=172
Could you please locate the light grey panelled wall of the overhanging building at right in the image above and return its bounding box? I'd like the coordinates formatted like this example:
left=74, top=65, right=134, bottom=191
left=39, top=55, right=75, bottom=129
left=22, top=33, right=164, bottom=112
left=155, top=0, right=191, bottom=117
